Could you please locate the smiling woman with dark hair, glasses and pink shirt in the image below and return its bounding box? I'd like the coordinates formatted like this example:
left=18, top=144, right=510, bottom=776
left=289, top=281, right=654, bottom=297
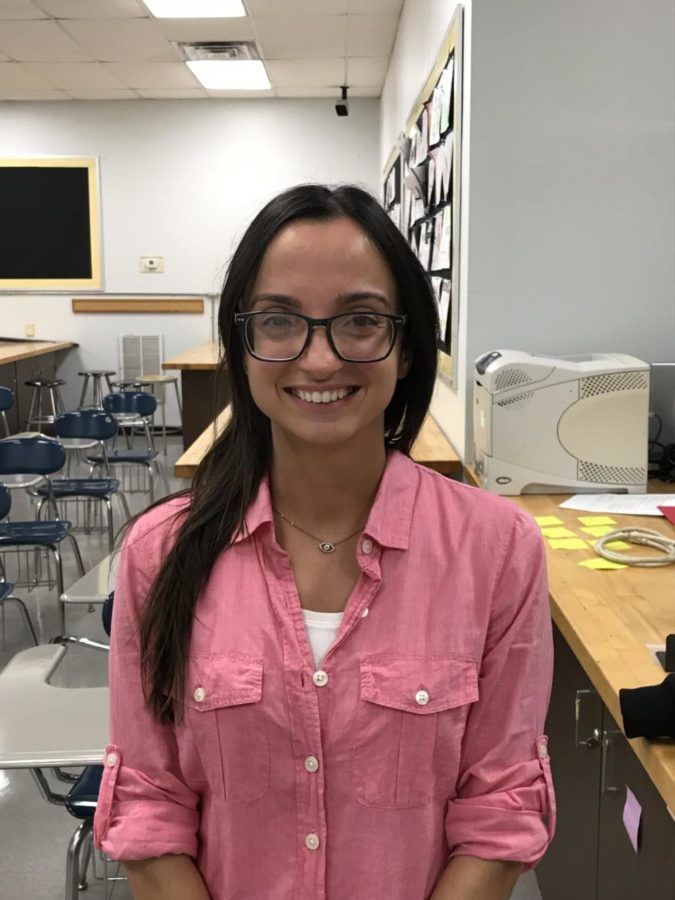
left=96, top=185, right=553, bottom=900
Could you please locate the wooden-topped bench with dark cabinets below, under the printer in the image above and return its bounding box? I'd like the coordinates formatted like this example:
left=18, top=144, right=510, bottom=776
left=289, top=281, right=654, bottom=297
left=492, top=482, right=675, bottom=900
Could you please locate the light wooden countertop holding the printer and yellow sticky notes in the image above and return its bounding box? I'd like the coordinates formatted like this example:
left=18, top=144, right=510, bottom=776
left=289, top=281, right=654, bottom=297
left=508, top=482, right=675, bottom=814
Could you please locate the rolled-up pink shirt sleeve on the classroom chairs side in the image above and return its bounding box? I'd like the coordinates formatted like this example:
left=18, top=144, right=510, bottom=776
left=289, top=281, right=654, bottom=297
left=94, top=510, right=199, bottom=860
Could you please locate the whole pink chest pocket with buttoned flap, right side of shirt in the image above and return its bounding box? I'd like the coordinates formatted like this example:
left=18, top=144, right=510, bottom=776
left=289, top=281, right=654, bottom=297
left=352, top=655, right=478, bottom=808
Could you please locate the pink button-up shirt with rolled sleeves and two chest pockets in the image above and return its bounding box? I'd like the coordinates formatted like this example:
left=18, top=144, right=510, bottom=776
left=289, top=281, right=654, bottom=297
left=95, top=452, right=554, bottom=900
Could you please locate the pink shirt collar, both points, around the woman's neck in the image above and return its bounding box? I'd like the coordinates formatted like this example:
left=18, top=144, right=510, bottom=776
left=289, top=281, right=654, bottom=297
left=234, top=450, right=419, bottom=550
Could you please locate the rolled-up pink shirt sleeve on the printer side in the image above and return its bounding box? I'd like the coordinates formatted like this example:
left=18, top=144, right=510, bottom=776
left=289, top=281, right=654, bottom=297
left=446, top=511, right=555, bottom=868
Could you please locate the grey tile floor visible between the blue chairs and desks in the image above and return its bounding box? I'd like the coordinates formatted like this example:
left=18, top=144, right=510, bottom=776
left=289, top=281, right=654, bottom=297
left=0, top=437, right=541, bottom=900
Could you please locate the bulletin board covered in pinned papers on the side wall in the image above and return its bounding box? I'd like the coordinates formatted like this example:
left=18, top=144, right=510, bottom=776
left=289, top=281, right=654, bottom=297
left=383, top=6, right=462, bottom=387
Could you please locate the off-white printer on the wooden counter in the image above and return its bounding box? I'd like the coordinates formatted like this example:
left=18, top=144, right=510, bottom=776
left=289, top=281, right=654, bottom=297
left=473, top=350, right=649, bottom=494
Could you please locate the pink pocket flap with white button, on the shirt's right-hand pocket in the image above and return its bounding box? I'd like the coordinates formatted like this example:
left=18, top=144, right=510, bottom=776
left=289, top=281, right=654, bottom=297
left=361, top=656, right=478, bottom=715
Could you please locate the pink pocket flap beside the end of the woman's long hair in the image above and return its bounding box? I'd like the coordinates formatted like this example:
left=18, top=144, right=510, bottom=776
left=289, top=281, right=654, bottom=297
left=185, top=653, right=263, bottom=712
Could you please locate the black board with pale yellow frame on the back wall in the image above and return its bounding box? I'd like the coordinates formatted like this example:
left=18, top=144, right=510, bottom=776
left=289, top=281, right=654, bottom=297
left=0, top=157, right=101, bottom=292
